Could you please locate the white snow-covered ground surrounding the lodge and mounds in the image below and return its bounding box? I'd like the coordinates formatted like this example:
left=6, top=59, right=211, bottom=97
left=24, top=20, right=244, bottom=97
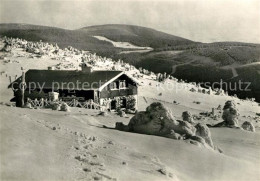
left=0, top=38, right=260, bottom=181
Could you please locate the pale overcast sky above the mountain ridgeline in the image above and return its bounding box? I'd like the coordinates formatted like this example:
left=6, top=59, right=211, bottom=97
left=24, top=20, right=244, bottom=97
left=0, top=0, right=260, bottom=43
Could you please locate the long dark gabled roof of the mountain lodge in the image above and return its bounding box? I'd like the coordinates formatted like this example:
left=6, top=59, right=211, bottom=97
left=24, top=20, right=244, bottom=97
left=8, top=70, right=123, bottom=90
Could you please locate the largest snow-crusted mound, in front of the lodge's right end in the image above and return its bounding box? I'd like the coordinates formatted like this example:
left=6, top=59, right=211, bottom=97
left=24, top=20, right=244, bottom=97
left=116, top=102, right=215, bottom=149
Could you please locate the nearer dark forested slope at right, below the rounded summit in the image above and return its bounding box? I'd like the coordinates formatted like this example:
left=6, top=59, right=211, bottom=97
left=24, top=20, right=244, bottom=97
left=113, top=47, right=260, bottom=102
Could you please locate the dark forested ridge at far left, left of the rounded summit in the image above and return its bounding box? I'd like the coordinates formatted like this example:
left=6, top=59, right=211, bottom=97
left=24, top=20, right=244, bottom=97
left=0, top=24, right=113, bottom=51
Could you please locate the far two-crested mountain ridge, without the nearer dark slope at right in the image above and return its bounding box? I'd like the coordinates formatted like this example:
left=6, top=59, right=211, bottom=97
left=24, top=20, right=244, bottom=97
left=0, top=24, right=194, bottom=53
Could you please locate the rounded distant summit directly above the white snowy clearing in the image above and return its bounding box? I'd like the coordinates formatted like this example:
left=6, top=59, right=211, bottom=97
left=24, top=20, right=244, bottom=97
left=80, top=24, right=195, bottom=48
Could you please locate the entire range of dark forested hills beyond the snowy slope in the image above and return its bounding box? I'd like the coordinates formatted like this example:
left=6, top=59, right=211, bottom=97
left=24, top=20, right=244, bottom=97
left=0, top=24, right=260, bottom=101
